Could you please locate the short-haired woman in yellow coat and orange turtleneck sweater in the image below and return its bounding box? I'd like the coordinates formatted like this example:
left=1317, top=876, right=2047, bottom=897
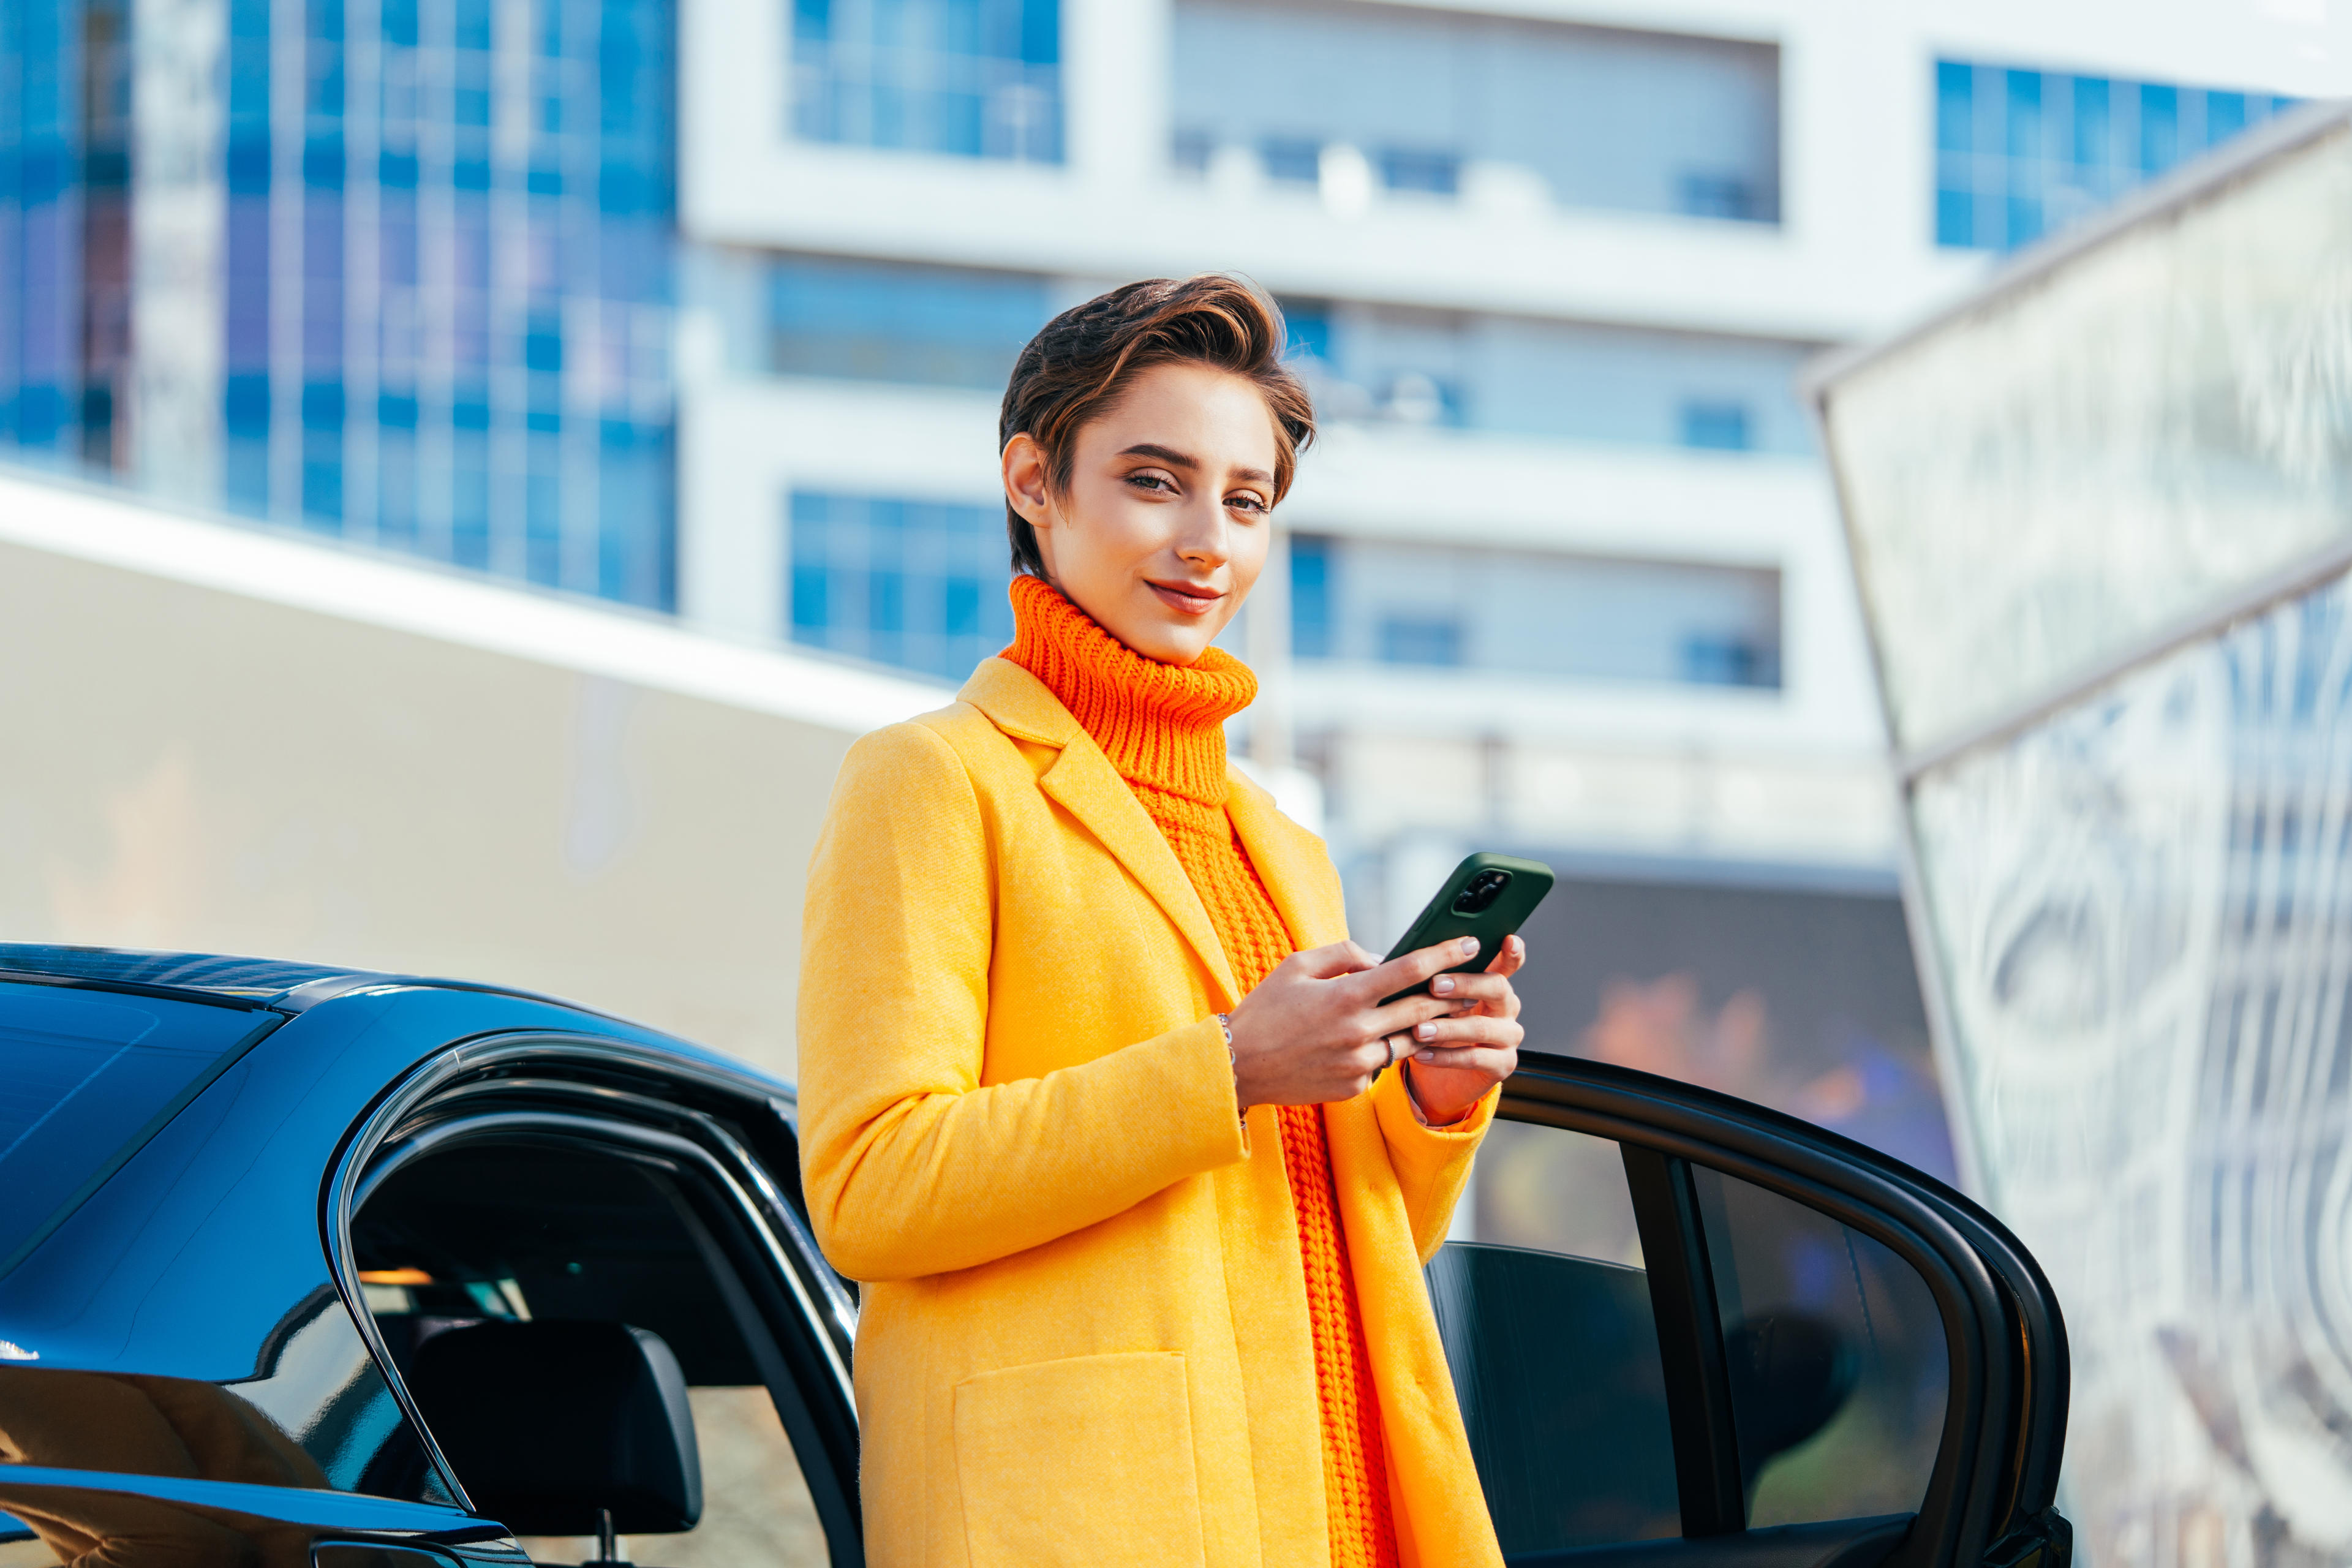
left=800, top=277, right=1524, bottom=1568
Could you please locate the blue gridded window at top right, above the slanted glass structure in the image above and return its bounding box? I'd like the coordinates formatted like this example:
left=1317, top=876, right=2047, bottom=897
left=1936, top=59, right=2293, bottom=249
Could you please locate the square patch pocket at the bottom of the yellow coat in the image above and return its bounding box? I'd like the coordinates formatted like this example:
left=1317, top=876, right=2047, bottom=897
left=955, top=1349, right=1207, bottom=1568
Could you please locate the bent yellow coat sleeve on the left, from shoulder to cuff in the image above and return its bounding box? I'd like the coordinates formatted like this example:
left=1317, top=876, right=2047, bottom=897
left=797, top=722, right=1246, bottom=1281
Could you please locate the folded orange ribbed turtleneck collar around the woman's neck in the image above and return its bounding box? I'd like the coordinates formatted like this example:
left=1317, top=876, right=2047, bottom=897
left=1005, top=576, right=1258, bottom=806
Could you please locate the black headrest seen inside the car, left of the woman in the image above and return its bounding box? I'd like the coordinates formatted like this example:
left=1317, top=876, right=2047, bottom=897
left=407, top=1319, right=703, bottom=1566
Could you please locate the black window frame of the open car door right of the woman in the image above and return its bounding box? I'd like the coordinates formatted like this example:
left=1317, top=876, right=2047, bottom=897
left=1496, top=1051, right=2070, bottom=1568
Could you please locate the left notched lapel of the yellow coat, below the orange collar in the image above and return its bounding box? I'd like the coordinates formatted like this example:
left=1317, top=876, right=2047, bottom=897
left=960, top=658, right=1251, bottom=1009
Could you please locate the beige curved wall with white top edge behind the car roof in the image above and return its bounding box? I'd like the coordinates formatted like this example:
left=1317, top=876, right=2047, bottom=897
left=0, top=475, right=948, bottom=1074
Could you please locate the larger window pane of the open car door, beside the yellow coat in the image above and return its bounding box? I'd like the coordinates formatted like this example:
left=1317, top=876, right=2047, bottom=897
left=1428, top=1121, right=1682, bottom=1556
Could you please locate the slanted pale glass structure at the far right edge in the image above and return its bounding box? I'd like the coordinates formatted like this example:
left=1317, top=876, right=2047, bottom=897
left=1823, top=110, right=2352, bottom=1568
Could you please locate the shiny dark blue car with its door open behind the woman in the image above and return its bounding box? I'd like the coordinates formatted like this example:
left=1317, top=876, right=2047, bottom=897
left=0, top=945, right=2067, bottom=1568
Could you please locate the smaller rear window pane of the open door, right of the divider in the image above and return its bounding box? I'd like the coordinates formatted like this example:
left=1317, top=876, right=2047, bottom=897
left=1691, top=1166, right=1950, bottom=1526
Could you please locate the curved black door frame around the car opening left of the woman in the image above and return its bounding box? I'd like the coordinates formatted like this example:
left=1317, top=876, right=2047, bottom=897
left=320, top=1027, right=863, bottom=1568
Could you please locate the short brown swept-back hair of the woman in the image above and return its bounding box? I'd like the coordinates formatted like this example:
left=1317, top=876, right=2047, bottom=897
left=997, top=273, right=1315, bottom=578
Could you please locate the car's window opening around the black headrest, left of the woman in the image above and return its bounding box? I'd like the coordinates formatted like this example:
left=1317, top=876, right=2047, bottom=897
left=353, top=1142, right=828, bottom=1568
